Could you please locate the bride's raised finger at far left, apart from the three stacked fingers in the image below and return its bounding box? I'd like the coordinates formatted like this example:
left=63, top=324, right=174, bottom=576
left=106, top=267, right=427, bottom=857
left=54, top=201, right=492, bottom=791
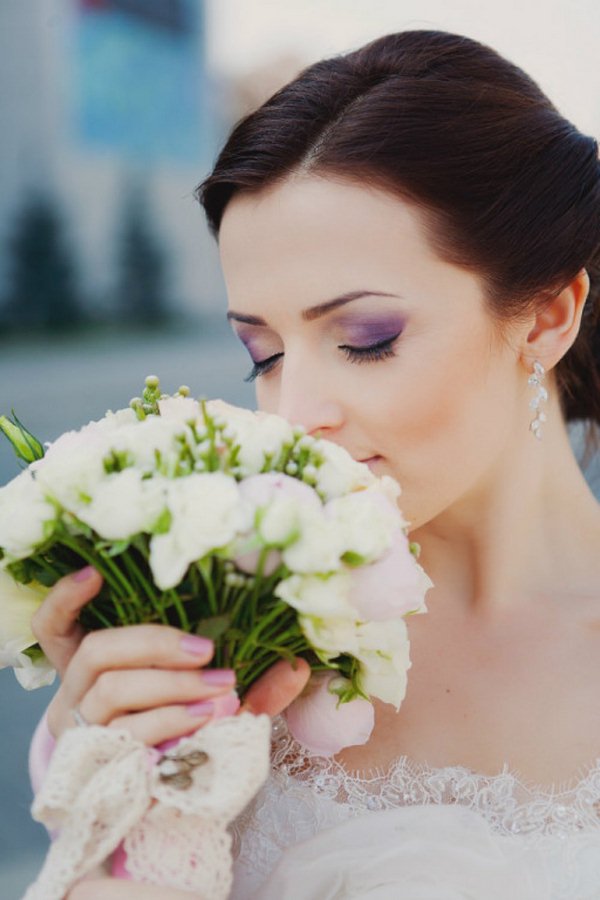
left=31, top=566, right=102, bottom=675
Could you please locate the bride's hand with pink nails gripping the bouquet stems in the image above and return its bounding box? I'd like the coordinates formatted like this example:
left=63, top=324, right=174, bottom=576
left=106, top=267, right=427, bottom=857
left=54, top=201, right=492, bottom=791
left=32, top=568, right=310, bottom=745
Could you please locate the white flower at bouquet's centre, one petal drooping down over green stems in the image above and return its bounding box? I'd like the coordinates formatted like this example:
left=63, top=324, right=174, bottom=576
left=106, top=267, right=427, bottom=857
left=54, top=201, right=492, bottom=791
left=150, top=472, right=249, bottom=590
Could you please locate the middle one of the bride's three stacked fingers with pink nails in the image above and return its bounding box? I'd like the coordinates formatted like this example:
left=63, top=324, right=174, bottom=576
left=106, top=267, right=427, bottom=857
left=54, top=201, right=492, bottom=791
left=78, top=669, right=235, bottom=725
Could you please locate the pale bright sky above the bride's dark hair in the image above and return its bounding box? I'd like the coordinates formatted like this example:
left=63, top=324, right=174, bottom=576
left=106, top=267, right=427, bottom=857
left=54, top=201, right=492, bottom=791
left=206, top=0, right=600, bottom=136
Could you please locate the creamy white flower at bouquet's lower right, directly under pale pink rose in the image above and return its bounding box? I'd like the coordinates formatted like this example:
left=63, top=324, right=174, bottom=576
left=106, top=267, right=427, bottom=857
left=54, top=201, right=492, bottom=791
left=352, top=619, right=411, bottom=709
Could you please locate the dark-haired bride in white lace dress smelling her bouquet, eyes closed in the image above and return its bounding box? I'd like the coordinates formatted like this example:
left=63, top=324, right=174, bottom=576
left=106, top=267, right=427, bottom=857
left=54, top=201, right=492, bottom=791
left=33, top=31, right=600, bottom=900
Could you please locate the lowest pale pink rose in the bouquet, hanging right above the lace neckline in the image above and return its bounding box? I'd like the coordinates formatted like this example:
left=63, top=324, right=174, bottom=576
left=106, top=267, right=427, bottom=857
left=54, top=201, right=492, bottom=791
left=285, top=672, right=375, bottom=756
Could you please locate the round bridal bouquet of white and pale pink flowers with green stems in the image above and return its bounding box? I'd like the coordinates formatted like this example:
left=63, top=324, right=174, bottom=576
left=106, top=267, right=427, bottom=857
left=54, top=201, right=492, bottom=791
left=0, top=376, right=431, bottom=896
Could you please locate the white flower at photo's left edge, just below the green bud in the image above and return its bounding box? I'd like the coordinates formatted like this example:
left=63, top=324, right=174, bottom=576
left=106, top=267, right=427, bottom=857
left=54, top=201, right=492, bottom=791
left=0, top=469, right=56, bottom=559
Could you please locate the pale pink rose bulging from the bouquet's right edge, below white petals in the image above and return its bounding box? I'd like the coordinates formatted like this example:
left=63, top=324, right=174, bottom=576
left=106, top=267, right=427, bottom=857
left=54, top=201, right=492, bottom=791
left=348, top=529, right=433, bottom=622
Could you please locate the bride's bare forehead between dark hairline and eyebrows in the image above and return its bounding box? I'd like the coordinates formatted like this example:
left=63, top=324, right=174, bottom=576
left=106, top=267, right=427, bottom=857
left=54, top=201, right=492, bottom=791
left=219, top=175, right=486, bottom=318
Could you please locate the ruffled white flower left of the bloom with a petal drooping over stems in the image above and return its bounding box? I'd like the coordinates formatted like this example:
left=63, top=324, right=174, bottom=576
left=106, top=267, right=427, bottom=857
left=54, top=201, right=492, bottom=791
left=78, top=469, right=166, bottom=541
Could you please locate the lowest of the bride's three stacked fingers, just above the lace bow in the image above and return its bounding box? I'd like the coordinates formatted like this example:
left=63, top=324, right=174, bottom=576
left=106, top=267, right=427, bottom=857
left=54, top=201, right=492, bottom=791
left=109, top=693, right=240, bottom=747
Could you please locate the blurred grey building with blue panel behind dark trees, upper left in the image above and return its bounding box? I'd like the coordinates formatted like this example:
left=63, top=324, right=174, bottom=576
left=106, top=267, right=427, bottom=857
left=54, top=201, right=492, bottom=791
left=0, top=0, right=222, bottom=324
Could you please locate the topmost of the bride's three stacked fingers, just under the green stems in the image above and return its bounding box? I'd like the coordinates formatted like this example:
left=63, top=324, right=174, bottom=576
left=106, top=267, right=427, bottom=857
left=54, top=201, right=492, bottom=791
left=64, top=625, right=214, bottom=705
